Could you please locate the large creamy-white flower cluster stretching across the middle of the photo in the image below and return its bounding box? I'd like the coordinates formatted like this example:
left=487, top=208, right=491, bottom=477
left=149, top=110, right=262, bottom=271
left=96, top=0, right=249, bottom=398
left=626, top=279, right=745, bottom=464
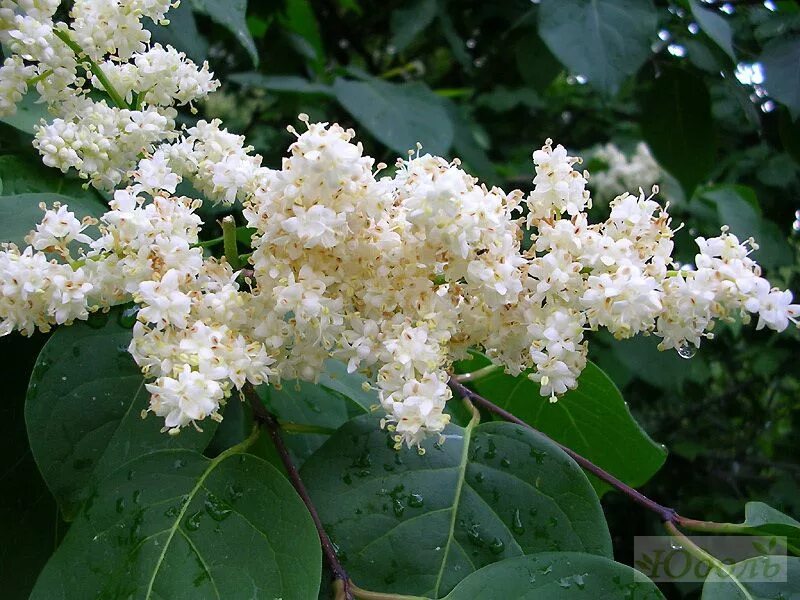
left=0, top=0, right=800, bottom=447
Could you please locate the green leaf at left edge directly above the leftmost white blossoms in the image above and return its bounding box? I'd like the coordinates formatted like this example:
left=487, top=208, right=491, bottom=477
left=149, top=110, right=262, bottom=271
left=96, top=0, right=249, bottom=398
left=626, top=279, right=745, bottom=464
left=0, top=194, right=107, bottom=249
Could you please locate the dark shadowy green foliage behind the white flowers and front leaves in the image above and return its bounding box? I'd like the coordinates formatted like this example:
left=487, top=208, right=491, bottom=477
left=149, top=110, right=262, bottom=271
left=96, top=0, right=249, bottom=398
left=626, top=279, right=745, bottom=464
left=0, top=0, right=800, bottom=599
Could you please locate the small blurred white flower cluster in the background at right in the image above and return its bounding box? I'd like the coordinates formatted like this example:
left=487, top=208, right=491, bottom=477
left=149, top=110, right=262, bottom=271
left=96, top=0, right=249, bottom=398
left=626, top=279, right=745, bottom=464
left=590, top=142, right=663, bottom=198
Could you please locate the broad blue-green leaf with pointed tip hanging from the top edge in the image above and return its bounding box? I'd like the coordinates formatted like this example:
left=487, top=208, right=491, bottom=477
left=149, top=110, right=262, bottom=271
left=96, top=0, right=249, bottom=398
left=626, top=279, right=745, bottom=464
left=539, top=0, right=658, bottom=95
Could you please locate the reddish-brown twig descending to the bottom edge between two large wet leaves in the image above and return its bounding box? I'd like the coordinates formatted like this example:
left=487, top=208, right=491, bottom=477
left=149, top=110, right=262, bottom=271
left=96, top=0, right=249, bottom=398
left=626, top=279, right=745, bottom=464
left=243, top=383, right=353, bottom=600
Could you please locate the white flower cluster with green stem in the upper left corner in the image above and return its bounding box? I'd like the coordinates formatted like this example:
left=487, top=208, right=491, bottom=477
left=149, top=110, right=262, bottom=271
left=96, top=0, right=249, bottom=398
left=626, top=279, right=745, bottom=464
left=0, top=0, right=219, bottom=190
